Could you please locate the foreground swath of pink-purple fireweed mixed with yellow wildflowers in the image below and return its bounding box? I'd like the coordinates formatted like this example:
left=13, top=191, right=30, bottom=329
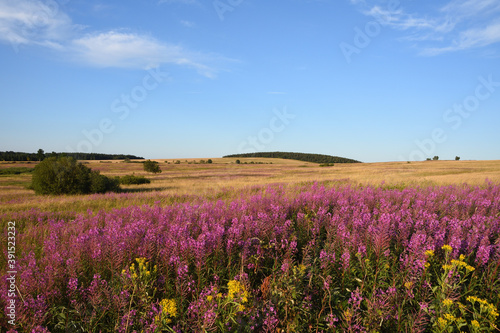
left=0, top=183, right=500, bottom=333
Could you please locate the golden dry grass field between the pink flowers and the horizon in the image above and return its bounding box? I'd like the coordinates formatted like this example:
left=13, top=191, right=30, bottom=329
left=0, top=158, right=500, bottom=213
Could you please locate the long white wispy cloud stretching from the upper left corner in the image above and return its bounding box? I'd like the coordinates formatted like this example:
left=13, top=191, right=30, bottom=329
left=0, top=0, right=227, bottom=78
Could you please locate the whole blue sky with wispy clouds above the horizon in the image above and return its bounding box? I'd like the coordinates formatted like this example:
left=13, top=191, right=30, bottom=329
left=0, top=0, right=500, bottom=162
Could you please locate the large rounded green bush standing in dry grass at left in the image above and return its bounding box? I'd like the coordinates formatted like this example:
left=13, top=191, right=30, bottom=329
left=31, top=157, right=120, bottom=194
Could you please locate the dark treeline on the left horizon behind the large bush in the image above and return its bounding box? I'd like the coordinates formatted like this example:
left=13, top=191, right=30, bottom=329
left=0, top=149, right=144, bottom=161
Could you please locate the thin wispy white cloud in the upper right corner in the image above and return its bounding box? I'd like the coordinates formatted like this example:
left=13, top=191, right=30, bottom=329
left=350, top=0, right=500, bottom=56
